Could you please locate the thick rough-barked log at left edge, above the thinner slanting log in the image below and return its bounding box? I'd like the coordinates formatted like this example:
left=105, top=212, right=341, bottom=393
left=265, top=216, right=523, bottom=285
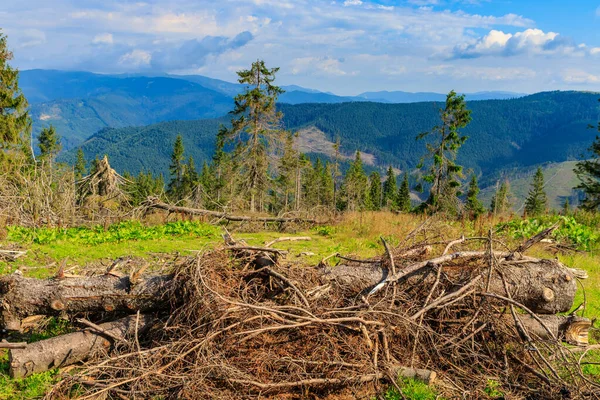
left=0, top=274, right=176, bottom=331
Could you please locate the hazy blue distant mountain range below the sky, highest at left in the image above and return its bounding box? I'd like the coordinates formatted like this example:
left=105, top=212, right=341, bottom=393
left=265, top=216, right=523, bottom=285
left=19, top=70, right=522, bottom=150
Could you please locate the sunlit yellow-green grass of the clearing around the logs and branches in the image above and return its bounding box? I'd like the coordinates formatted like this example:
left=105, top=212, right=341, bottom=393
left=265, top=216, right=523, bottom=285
left=0, top=212, right=600, bottom=400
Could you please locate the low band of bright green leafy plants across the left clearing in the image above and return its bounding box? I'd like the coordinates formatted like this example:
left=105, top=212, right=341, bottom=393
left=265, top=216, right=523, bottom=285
left=7, top=221, right=220, bottom=245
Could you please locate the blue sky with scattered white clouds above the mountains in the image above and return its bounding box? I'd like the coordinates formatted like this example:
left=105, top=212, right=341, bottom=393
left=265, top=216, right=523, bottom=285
left=0, top=0, right=600, bottom=95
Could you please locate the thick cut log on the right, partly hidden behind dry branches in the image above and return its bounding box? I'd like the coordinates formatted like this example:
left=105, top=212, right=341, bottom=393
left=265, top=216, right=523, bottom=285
left=324, top=252, right=577, bottom=314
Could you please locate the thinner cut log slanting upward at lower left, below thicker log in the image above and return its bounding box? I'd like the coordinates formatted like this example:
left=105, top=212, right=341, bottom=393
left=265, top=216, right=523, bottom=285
left=9, top=314, right=154, bottom=378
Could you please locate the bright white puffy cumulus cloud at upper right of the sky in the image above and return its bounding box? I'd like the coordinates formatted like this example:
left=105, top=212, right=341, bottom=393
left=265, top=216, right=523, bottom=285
left=452, top=29, right=586, bottom=58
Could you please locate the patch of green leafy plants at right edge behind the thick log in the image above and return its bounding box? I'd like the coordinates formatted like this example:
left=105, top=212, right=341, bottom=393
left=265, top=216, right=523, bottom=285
left=496, top=215, right=600, bottom=251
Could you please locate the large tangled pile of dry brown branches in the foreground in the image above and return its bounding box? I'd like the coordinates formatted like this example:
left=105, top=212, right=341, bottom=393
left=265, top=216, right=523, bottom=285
left=0, top=228, right=600, bottom=399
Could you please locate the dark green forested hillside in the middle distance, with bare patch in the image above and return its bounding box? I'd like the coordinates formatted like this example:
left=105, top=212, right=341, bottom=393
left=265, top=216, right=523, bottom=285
left=63, top=92, right=599, bottom=206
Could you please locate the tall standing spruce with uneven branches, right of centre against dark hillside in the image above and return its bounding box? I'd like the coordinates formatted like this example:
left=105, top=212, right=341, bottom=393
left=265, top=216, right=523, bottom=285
left=417, top=91, right=471, bottom=214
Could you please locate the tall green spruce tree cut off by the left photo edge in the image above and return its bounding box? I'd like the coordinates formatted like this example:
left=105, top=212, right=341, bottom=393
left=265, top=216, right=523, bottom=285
left=0, top=29, right=31, bottom=152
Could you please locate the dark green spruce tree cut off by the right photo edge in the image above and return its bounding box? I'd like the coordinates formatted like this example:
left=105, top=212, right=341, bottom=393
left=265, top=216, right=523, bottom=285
left=575, top=114, right=600, bottom=210
